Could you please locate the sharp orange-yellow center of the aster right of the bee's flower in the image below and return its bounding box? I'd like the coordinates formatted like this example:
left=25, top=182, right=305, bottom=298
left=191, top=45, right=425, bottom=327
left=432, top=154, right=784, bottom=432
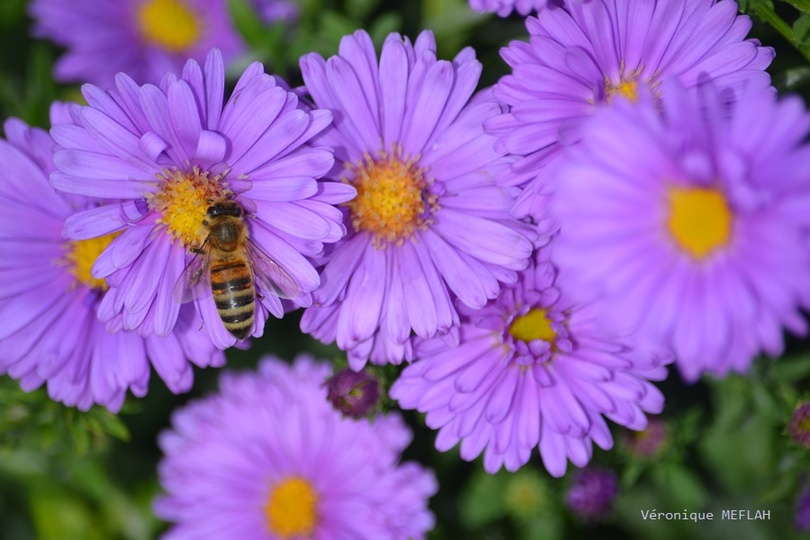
left=346, top=148, right=438, bottom=248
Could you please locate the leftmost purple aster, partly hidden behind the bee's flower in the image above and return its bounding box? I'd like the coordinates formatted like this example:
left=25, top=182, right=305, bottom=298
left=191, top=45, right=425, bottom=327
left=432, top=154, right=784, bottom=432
left=0, top=104, right=225, bottom=411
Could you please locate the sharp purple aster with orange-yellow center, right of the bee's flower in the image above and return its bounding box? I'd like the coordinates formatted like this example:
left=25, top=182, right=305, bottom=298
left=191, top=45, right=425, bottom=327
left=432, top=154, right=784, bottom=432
left=301, top=31, right=533, bottom=370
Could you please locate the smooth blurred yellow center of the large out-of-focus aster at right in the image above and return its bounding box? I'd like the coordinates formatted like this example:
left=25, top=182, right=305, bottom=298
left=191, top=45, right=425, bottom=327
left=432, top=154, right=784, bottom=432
left=667, top=186, right=733, bottom=259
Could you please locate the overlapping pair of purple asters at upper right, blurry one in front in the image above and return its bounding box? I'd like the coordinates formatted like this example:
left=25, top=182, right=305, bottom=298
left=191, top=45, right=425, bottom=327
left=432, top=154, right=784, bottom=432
left=485, top=0, right=810, bottom=381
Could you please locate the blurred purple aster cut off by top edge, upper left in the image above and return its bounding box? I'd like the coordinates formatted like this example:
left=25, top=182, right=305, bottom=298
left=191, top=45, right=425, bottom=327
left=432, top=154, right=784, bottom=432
left=30, top=0, right=245, bottom=88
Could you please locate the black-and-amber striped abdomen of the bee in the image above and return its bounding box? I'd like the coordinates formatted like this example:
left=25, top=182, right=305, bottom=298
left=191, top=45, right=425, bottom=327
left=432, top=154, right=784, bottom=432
left=211, top=261, right=256, bottom=339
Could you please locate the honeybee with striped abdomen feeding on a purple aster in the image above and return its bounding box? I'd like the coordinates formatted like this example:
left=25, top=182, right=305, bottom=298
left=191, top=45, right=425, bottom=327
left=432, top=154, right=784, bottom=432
left=175, top=198, right=299, bottom=340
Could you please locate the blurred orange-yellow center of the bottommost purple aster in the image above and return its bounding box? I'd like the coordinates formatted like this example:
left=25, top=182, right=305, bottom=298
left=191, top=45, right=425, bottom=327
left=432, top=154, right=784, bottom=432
left=265, top=476, right=318, bottom=539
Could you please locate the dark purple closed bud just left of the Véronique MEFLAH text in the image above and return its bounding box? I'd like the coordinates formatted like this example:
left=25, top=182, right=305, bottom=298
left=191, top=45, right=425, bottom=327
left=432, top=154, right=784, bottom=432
left=565, top=468, right=619, bottom=522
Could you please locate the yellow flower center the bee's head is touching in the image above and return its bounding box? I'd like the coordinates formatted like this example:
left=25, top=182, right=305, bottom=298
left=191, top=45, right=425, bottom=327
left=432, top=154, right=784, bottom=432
left=146, top=167, right=230, bottom=247
